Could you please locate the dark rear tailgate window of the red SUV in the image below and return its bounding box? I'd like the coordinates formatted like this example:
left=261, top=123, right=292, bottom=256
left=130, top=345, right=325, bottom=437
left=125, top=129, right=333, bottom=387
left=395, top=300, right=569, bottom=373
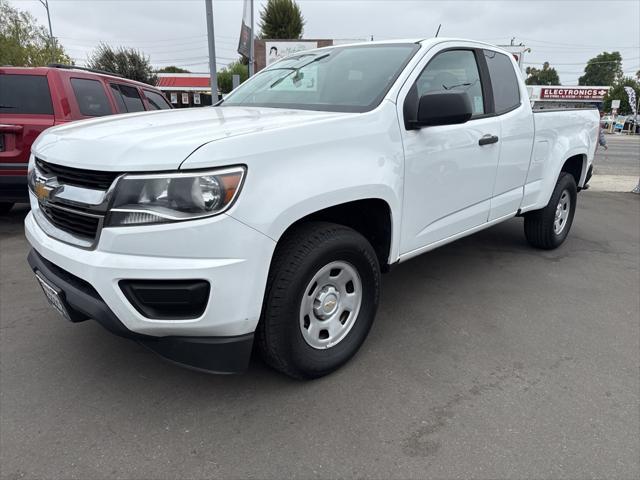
left=0, top=74, right=53, bottom=115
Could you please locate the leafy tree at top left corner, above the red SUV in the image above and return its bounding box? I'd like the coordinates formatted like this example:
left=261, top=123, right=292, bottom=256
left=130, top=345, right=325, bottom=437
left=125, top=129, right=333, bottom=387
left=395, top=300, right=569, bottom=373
left=0, top=0, right=73, bottom=67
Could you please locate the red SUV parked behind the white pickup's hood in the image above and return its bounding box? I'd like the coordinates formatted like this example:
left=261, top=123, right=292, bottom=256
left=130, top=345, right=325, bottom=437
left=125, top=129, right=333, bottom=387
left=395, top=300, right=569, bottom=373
left=0, top=65, right=171, bottom=213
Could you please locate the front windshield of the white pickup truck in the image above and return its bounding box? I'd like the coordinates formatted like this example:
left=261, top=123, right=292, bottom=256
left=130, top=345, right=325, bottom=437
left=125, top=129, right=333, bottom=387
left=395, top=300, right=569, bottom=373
left=222, top=43, right=419, bottom=112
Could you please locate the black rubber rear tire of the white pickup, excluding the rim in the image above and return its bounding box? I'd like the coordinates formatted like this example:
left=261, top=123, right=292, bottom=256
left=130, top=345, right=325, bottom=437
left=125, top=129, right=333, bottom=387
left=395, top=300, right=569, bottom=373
left=524, top=172, right=577, bottom=250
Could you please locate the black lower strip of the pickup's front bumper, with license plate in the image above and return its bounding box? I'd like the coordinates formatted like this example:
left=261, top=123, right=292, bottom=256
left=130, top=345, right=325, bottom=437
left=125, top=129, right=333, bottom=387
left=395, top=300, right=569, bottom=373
left=28, top=249, right=253, bottom=373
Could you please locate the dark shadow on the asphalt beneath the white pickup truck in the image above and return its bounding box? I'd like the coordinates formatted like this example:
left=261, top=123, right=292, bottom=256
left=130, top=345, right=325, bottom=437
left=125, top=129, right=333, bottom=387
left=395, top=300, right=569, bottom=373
left=69, top=214, right=540, bottom=391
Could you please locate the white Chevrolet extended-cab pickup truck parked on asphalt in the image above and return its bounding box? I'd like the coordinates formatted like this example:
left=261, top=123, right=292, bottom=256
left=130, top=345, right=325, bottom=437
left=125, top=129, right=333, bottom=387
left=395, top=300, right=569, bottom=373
left=25, top=38, right=598, bottom=378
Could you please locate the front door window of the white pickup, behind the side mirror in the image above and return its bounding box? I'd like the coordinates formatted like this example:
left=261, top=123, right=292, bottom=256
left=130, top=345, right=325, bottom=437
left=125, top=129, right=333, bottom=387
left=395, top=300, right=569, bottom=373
left=416, top=50, right=484, bottom=115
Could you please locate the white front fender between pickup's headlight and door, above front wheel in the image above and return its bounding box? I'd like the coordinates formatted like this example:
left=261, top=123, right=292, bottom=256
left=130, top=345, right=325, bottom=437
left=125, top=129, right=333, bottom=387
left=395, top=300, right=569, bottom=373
left=184, top=101, right=404, bottom=258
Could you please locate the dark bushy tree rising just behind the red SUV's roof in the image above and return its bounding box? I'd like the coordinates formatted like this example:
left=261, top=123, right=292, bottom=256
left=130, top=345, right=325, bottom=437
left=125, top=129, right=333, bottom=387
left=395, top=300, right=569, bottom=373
left=88, top=43, right=158, bottom=85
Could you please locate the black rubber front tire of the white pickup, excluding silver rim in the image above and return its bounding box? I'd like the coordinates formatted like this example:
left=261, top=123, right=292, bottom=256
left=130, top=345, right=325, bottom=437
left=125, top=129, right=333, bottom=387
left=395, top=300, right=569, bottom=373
left=256, top=222, right=380, bottom=379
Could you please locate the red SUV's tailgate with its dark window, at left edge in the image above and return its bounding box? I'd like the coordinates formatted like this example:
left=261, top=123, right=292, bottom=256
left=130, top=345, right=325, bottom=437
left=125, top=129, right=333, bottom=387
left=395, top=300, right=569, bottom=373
left=0, top=74, right=54, bottom=177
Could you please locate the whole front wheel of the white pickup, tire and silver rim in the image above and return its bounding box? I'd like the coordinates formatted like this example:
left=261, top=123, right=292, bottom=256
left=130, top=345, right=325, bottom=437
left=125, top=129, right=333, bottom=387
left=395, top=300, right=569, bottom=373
left=256, top=222, right=380, bottom=378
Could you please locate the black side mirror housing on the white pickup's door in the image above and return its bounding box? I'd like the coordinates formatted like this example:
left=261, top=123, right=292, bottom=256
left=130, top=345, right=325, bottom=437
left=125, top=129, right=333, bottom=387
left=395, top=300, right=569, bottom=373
left=408, top=91, right=473, bottom=129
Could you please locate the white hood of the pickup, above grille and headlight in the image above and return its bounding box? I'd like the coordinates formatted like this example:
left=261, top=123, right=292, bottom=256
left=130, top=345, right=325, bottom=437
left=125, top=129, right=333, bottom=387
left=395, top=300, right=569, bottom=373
left=32, top=107, right=349, bottom=172
